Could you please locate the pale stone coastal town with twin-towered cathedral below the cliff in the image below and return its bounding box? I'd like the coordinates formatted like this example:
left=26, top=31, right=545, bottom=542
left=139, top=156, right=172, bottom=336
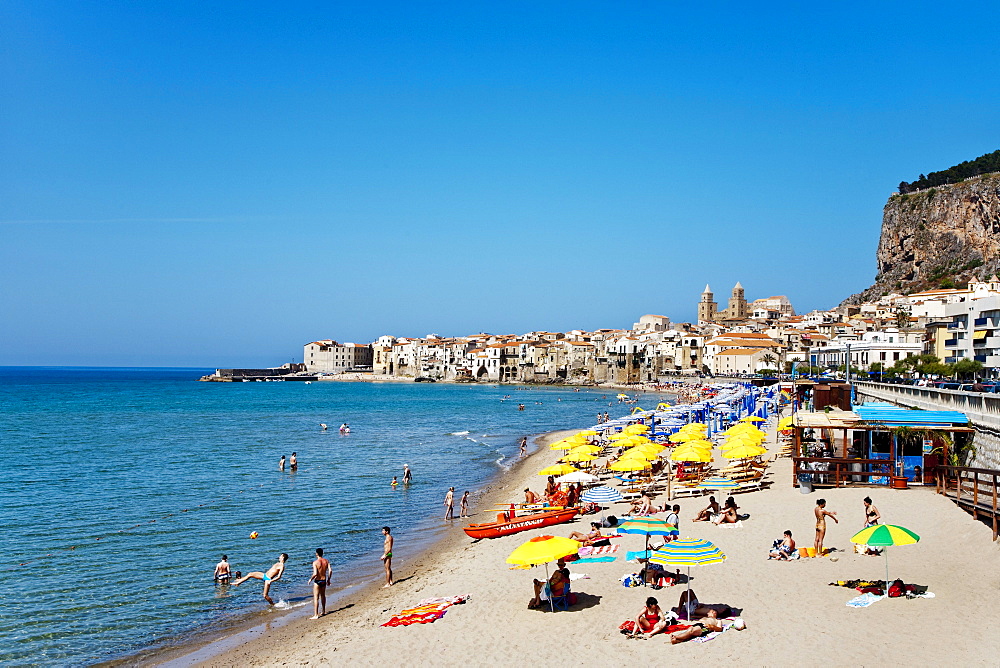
left=248, top=275, right=1000, bottom=385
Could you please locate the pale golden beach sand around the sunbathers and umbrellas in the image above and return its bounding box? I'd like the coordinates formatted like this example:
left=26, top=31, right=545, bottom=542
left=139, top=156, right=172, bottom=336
left=182, top=426, right=1000, bottom=666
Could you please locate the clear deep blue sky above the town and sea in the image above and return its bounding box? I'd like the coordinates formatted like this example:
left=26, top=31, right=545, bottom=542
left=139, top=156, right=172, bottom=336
left=0, top=0, right=1000, bottom=366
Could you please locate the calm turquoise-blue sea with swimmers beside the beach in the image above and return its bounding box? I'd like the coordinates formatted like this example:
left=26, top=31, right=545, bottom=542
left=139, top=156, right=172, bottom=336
left=0, top=367, right=672, bottom=665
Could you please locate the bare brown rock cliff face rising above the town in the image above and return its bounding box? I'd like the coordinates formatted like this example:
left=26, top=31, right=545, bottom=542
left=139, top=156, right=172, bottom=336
left=844, top=174, right=1000, bottom=304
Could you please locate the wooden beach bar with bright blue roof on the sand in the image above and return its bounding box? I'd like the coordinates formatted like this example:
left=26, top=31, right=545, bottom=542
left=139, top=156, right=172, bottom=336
left=792, top=402, right=975, bottom=489
